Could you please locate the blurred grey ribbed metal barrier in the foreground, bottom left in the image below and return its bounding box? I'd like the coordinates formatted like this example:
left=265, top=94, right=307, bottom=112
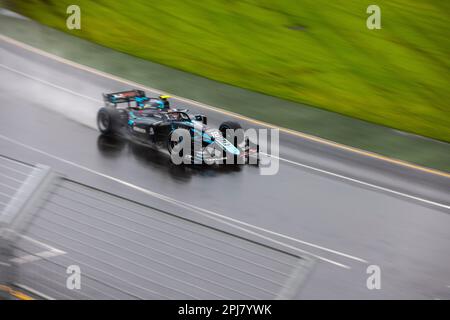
left=0, top=157, right=313, bottom=299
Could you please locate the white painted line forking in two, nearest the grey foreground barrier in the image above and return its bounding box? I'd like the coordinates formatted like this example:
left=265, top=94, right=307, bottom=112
left=0, top=134, right=368, bottom=269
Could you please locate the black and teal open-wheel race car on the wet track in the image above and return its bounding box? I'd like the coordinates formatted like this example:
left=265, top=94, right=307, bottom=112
left=97, top=89, right=259, bottom=165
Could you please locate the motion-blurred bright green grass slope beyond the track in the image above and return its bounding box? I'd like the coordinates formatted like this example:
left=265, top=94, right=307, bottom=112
left=7, top=0, right=450, bottom=142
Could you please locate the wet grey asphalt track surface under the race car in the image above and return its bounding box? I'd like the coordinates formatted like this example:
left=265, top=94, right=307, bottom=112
left=0, top=41, right=450, bottom=299
